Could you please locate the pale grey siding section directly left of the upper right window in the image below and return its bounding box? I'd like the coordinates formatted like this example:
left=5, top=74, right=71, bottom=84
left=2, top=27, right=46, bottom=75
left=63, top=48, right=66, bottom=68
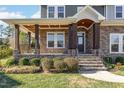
left=106, top=5, right=115, bottom=20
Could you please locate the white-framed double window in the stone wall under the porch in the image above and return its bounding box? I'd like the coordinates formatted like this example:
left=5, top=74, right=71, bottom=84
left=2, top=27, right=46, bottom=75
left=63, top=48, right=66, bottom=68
left=47, top=32, right=65, bottom=48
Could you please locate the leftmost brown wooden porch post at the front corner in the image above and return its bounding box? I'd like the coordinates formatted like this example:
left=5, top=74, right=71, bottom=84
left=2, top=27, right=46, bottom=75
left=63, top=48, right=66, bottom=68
left=14, top=24, right=20, bottom=55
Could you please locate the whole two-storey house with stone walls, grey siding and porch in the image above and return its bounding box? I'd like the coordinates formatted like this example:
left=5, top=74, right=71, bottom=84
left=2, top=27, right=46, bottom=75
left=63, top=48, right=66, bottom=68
left=1, top=5, right=124, bottom=60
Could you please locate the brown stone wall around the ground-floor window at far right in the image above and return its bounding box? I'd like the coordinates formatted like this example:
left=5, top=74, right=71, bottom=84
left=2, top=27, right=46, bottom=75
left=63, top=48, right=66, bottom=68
left=100, top=26, right=124, bottom=58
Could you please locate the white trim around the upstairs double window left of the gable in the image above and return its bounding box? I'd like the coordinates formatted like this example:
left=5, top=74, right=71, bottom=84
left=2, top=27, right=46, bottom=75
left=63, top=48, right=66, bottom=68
left=47, top=5, right=65, bottom=19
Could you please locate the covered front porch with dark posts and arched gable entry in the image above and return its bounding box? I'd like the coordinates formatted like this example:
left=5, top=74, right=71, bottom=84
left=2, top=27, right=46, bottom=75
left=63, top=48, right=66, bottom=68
left=2, top=6, right=104, bottom=57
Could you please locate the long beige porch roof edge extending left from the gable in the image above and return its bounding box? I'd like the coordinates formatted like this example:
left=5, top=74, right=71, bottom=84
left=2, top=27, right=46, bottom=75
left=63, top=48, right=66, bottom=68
left=0, top=18, right=76, bottom=25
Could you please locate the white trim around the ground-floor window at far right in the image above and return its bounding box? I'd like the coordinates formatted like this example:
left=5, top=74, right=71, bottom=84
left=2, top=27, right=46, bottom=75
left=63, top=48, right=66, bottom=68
left=109, top=33, right=124, bottom=54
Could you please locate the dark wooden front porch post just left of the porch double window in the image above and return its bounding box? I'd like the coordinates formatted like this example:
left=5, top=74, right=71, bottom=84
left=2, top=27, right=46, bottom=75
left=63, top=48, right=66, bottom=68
left=35, top=24, right=40, bottom=54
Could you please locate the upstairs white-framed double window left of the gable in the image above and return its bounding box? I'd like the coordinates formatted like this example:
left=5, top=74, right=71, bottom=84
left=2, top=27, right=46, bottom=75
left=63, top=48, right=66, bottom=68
left=47, top=6, right=65, bottom=18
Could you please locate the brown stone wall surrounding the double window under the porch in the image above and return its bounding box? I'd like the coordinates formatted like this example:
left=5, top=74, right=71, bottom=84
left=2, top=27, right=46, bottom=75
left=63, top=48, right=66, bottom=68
left=40, top=30, right=68, bottom=53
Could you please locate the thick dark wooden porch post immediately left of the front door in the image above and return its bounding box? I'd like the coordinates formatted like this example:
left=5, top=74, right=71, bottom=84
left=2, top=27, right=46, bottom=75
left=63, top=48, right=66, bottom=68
left=68, top=23, right=77, bottom=55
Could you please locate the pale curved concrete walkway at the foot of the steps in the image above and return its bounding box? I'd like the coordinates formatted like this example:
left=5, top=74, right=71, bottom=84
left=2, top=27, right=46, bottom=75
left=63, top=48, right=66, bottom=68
left=81, top=71, right=124, bottom=83
